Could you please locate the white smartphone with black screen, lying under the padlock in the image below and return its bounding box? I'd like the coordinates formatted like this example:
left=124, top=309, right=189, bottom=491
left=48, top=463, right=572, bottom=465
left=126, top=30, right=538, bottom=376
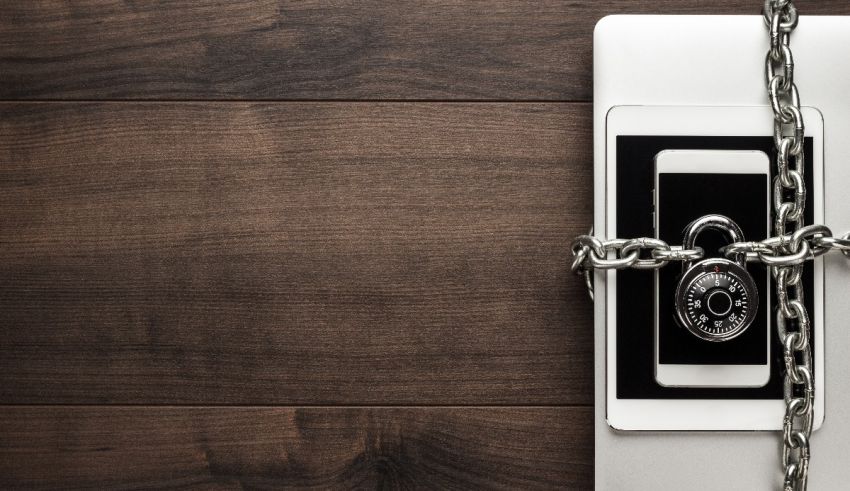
left=653, top=150, right=771, bottom=387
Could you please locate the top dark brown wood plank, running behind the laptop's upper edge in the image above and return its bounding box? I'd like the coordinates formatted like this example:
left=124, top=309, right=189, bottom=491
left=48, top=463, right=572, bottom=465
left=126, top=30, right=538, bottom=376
left=0, top=0, right=850, bottom=101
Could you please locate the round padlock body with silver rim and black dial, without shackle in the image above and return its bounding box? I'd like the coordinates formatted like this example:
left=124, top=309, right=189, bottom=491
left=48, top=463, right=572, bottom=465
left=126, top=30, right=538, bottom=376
left=676, top=258, right=758, bottom=341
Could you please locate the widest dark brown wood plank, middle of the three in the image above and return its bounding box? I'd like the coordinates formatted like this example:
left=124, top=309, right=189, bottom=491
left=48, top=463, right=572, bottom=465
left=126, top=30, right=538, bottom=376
left=0, top=103, right=592, bottom=405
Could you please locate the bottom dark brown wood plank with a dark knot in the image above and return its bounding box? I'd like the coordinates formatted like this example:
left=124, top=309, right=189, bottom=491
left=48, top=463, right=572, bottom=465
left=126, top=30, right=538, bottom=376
left=0, top=407, right=593, bottom=490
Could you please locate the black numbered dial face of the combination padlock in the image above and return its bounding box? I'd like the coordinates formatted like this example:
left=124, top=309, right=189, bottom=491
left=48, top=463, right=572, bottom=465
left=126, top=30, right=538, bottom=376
left=686, top=272, right=749, bottom=335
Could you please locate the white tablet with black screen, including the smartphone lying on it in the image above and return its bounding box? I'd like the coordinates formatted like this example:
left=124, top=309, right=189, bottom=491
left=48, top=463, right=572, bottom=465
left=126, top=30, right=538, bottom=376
left=596, top=106, right=824, bottom=430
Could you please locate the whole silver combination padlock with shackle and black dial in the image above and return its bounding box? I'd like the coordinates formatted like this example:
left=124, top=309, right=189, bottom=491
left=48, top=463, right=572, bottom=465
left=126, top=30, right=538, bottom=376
left=676, top=215, right=759, bottom=342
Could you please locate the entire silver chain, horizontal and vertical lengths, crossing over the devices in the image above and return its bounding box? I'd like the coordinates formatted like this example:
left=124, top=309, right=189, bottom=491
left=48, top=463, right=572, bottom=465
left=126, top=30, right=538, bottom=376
left=571, top=0, right=850, bottom=491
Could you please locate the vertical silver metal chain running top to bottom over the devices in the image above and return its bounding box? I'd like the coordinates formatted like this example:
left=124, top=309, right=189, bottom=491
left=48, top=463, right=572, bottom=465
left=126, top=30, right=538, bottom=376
left=758, top=0, right=812, bottom=491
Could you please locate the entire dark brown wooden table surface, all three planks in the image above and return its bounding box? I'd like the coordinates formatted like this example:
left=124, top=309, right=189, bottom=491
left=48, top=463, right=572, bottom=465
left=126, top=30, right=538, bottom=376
left=0, top=0, right=850, bottom=489
